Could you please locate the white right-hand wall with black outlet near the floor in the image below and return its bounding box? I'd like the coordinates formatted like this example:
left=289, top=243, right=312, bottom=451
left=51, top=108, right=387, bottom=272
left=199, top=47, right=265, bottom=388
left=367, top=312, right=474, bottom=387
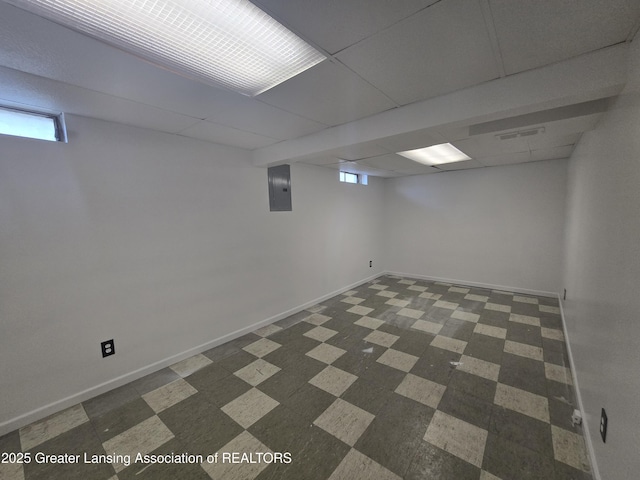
left=563, top=40, right=640, bottom=480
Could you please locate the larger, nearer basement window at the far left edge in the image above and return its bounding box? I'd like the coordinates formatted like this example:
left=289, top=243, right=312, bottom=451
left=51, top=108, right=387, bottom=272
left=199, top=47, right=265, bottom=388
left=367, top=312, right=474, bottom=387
left=0, top=107, right=67, bottom=142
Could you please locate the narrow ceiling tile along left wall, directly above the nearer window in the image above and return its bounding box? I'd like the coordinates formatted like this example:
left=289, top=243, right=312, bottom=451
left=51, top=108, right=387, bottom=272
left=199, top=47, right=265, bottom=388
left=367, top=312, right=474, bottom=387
left=0, top=67, right=198, bottom=133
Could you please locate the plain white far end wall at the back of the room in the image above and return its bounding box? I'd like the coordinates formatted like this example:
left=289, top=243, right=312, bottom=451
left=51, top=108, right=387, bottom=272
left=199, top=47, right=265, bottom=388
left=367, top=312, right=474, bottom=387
left=385, top=160, right=566, bottom=293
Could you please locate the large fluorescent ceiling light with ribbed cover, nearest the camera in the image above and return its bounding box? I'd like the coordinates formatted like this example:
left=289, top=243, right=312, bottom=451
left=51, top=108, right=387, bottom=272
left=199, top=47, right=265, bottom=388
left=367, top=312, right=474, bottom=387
left=8, top=0, right=325, bottom=96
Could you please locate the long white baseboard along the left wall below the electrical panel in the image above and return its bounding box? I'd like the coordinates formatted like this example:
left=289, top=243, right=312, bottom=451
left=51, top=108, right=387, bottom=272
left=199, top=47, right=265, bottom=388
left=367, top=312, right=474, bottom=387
left=0, top=272, right=384, bottom=437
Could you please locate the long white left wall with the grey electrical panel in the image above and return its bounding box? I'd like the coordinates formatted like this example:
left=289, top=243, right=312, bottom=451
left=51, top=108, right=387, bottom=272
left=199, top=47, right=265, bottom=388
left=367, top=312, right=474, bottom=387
left=0, top=116, right=384, bottom=434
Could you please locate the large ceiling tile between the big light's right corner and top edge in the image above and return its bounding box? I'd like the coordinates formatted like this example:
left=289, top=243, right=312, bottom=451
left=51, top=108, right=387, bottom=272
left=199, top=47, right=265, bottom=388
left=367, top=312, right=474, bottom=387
left=337, top=0, right=499, bottom=105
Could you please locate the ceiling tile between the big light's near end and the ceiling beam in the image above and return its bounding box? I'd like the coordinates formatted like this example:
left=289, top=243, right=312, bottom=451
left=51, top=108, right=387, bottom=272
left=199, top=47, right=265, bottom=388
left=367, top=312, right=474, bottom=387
left=257, top=60, right=395, bottom=125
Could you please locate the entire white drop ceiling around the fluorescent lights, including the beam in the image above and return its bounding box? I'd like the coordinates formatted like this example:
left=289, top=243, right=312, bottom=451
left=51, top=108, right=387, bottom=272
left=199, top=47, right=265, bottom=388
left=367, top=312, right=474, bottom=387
left=0, top=0, right=640, bottom=177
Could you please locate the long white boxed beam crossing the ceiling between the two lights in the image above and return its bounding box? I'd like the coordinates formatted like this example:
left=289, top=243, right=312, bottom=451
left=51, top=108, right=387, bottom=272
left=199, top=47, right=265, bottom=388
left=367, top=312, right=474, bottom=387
left=252, top=43, right=628, bottom=167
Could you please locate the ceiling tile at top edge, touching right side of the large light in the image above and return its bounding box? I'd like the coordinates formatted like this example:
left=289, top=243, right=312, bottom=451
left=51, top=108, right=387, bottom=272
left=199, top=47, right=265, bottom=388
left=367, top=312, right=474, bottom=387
left=254, top=0, right=436, bottom=54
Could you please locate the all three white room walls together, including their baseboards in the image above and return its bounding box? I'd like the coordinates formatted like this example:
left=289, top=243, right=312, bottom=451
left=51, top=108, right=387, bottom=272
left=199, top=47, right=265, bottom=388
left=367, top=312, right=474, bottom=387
left=0, top=41, right=640, bottom=480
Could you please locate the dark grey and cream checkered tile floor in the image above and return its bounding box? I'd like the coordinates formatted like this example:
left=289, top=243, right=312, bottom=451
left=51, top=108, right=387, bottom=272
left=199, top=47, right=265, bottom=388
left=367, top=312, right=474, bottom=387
left=0, top=276, right=591, bottom=480
